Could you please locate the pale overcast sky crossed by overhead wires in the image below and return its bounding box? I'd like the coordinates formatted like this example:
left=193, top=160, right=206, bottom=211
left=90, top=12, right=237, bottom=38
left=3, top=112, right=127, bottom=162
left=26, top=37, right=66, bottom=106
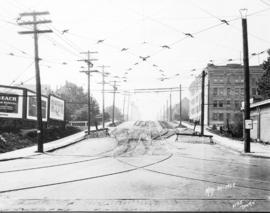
left=0, top=0, right=270, bottom=119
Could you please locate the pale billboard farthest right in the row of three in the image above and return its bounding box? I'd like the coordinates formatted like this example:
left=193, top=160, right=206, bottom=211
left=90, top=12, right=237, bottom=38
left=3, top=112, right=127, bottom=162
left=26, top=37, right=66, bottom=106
left=49, top=95, right=65, bottom=121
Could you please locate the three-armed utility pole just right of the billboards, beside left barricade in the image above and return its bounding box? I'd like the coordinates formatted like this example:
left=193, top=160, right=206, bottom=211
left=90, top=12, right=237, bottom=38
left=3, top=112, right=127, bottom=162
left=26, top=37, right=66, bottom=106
left=78, top=50, right=98, bottom=135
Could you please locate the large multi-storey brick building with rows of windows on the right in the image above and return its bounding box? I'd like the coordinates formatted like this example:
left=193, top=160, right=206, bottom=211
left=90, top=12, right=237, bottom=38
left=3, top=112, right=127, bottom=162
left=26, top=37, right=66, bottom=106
left=189, top=64, right=264, bottom=126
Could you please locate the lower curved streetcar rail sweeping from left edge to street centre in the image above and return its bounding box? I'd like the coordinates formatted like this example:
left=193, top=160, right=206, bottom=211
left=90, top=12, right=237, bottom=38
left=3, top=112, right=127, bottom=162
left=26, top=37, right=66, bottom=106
left=0, top=154, right=173, bottom=194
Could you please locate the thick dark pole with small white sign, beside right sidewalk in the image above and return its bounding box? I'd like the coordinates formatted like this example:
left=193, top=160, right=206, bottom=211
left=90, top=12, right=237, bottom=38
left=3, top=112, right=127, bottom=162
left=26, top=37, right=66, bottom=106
left=240, top=9, right=251, bottom=152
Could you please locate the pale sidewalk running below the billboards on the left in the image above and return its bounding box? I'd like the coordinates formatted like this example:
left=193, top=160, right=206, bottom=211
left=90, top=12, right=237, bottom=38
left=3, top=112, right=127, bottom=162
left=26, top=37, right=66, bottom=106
left=0, top=131, right=85, bottom=161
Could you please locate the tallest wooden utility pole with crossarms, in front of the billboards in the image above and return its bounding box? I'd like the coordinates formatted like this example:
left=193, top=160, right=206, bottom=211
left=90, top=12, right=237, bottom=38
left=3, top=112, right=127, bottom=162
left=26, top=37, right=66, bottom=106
left=18, top=11, right=53, bottom=152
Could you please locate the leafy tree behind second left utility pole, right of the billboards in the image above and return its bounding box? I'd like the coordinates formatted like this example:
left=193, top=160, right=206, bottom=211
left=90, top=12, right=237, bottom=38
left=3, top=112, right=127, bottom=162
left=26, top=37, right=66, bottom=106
left=55, top=81, right=99, bottom=124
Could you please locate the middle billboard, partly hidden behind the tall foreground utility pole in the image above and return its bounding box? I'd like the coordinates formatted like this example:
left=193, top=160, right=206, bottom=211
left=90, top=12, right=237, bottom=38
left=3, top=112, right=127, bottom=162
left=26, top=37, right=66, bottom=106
left=26, top=91, right=48, bottom=121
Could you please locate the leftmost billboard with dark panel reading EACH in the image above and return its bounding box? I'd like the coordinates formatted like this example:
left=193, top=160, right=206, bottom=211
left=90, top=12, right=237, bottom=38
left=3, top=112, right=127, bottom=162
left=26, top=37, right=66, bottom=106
left=0, top=87, right=23, bottom=118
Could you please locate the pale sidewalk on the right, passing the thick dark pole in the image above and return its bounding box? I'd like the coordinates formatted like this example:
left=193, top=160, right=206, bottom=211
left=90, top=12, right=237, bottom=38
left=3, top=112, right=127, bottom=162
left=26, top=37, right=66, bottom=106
left=182, top=122, right=270, bottom=159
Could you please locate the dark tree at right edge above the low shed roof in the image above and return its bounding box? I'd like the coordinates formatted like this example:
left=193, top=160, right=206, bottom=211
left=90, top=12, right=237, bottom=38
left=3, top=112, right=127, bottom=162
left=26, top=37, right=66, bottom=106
left=258, top=49, right=270, bottom=100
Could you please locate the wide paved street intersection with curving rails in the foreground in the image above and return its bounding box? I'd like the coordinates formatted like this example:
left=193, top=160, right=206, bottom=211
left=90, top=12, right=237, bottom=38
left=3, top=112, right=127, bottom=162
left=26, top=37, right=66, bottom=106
left=0, top=125, right=270, bottom=211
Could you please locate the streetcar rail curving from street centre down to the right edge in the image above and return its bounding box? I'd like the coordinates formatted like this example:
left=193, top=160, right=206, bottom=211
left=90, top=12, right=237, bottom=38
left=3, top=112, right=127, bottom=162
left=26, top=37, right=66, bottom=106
left=117, top=159, right=270, bottom=192
